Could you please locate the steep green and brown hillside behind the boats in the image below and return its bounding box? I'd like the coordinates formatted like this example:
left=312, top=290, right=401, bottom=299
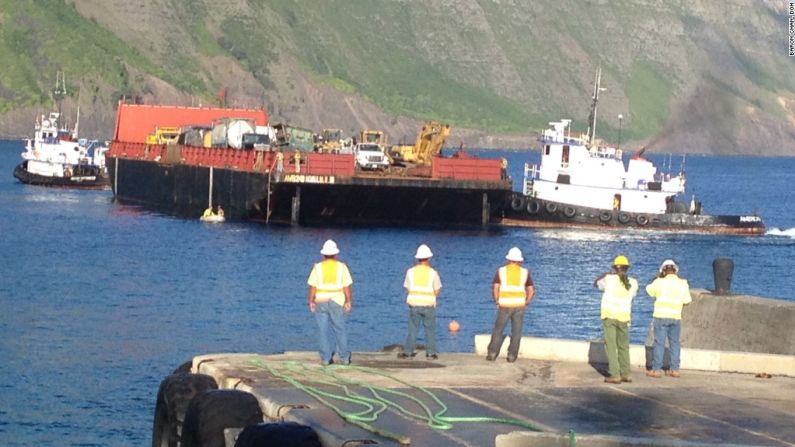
left=0, top=0, right=795, bottom=152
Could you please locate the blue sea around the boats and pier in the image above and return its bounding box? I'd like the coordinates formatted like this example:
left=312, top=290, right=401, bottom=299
left=0, top=142, right=795, bottom=446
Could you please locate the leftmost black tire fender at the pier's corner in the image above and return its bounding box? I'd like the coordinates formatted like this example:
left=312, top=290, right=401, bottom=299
left=152, top=372, right=218, bottom=447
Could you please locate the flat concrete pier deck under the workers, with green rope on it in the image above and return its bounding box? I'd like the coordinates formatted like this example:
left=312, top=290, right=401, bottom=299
left=193, top=350, right=795, bottom=447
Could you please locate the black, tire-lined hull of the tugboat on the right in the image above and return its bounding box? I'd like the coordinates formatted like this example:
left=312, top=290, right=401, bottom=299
left=499, top=193, right=765, bottom=235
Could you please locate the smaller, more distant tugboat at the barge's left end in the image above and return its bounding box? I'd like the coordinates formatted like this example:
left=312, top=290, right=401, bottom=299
left=14, top=72, right=110, bottom=189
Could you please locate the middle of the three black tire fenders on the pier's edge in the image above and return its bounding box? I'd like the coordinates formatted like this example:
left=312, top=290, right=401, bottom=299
left=180, top=390, right=262, bottom=447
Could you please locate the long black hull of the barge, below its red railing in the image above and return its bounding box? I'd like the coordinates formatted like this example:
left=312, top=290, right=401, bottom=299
left=108, top=157, right=510, bottom=228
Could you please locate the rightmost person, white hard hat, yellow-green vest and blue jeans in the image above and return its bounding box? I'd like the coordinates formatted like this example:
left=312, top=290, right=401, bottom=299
left=646, top=259, right=693, bottom=378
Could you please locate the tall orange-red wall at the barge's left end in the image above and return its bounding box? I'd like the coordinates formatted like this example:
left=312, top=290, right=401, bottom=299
left=113, top=102, right=268, bottom=143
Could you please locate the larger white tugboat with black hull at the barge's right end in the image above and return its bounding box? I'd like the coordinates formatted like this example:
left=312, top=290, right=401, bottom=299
left=501, top=70, right=765, bottom=235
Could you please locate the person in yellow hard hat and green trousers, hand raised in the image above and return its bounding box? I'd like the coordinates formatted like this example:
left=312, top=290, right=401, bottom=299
left=593, top=255, right=638, bottom=383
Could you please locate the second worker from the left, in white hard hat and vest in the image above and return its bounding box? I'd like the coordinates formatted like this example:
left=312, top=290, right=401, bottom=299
left=398, top=244, right=442, bottom=360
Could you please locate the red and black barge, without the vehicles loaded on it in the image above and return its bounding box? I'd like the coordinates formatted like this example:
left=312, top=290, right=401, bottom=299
left=107, top=103, right=511, bottom=227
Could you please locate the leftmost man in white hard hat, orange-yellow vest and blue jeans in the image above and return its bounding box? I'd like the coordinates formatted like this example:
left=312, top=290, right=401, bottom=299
left=307, top=239, right=353, bottom=365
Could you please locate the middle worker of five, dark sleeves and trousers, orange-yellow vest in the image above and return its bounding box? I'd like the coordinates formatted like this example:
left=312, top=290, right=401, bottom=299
left=486, top=247, right=536, bottom=363
